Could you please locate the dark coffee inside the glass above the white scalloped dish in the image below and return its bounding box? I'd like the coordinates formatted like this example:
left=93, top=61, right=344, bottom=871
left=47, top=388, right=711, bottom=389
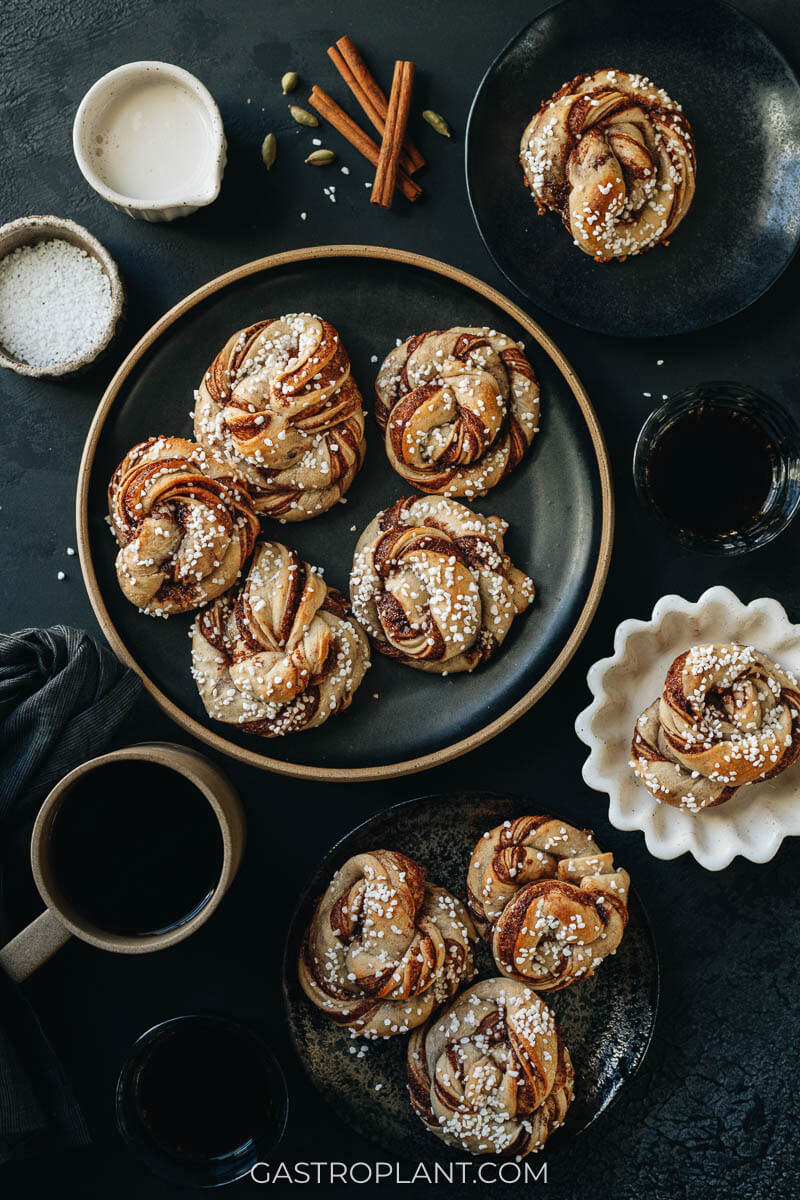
left=648, top=407, right=777, bottom=536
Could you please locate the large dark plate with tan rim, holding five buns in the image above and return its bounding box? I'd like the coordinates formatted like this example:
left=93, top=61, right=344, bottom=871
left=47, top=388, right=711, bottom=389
left=78, top=247, right=612, bottom=779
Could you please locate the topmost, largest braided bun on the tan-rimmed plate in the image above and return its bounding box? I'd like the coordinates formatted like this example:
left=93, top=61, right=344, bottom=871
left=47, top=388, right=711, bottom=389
left=194, top=313, right=366, bottom=521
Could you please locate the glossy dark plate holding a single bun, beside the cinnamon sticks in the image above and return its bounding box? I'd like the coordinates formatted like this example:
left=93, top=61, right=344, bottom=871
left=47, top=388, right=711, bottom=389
left=467, top=0, right=800, bottom=337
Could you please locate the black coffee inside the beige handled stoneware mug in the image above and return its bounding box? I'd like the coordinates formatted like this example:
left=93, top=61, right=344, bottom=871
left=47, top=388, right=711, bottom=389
left=50, top=761, right=223, bottom=936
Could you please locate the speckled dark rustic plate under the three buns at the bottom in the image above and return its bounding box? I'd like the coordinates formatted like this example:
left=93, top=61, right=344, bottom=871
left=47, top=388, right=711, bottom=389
left=283, top=792, right=658, bottom=1162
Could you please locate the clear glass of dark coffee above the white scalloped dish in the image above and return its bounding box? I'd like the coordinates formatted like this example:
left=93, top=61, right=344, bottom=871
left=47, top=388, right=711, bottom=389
left=633, top=383, right=800, bottom=554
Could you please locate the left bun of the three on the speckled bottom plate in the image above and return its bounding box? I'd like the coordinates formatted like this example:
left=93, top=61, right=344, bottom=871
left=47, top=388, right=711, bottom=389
left=297, top=850, right=475, bottom=1038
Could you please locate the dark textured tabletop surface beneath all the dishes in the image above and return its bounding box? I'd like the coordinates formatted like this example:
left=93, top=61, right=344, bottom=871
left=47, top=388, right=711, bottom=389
left=0, top=0, right=800, bottom=1200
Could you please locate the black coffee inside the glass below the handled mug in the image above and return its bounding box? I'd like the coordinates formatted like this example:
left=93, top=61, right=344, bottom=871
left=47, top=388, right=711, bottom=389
left=134, top=1016, right=279, bottom=1159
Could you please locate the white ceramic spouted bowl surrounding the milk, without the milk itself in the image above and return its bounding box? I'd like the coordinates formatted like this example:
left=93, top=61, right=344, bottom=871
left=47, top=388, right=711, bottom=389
left=72, top=60, right=228, bottom=221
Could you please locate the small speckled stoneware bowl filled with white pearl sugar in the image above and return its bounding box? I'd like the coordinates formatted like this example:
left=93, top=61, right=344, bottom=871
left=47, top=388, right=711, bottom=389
left=0, top=216, right=125, bottom=378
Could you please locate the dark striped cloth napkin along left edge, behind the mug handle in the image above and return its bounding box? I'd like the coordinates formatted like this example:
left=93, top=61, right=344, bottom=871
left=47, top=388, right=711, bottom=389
left=0, top=625, right=142, bottom=1164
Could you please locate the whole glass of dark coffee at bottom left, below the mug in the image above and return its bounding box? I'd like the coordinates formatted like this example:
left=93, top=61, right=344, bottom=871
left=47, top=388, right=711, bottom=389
left=116, top=1014, right=288, bottom=1188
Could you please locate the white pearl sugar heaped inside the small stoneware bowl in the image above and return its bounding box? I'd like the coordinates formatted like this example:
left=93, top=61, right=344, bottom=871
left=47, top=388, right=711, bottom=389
left=0, top=239, right=112, bottom=366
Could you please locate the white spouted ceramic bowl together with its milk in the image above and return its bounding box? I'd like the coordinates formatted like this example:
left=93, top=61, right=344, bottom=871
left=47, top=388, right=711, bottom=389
left=72, top=61, right=227, bottom=221
